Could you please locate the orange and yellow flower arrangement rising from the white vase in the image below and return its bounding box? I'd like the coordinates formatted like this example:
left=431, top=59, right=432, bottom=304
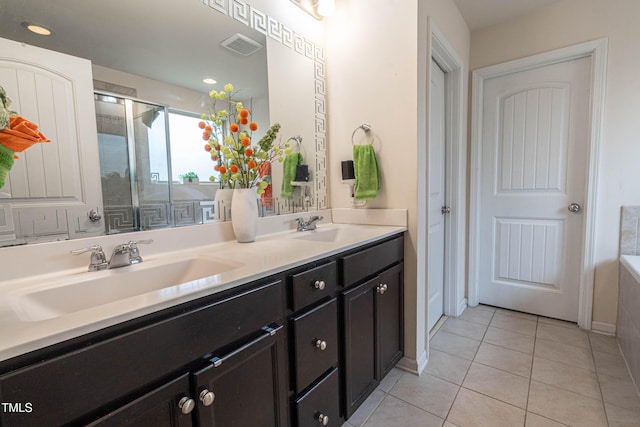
left=198, top=83, right=288, bottom=194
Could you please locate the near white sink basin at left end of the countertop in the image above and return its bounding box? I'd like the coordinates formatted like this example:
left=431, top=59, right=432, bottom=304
left=12, top=258, right=242, bottom=322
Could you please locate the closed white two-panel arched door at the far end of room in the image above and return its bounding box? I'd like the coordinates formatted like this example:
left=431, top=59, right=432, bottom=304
left=478, top=58, right=591, bottom=321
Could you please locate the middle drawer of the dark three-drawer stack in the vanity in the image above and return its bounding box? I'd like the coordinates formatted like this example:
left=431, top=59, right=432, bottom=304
left=292, top=298, right=338, bottom=393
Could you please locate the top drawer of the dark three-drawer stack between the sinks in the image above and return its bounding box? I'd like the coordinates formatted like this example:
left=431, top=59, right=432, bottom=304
left=290, top=261, right=338, bottom=311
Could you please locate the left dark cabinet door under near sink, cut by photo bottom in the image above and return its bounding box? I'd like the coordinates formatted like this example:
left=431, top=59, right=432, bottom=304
left=89, top=374, right=195, bottom=427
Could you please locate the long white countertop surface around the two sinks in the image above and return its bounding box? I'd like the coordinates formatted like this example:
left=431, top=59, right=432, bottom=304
left=0, top=223, right=406, bottom=361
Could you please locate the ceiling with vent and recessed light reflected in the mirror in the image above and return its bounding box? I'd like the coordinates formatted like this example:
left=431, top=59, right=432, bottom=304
left=0, top=0, right=266, bottom=96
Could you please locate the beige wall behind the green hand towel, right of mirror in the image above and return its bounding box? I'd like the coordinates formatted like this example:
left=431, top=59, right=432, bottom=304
left=326, top=0, right=469, bottom=368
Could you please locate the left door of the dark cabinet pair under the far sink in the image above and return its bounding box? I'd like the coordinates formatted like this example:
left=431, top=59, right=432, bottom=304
left=342, top=277, right=378, bottom=418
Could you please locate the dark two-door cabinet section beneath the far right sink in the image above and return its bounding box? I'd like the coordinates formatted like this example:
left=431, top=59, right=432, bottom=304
left=340, top=238, right=404, bottom=419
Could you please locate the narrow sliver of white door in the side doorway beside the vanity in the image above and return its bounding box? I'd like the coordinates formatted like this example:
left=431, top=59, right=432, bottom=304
left=427, top=59, right=446, bottom=331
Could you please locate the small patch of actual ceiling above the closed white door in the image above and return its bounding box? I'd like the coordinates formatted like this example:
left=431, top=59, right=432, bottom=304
left=453, top=0, right=562, bottom=31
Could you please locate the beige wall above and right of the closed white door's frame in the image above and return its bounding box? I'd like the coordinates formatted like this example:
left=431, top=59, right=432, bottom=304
left=471, top=0, right=640, bottom=324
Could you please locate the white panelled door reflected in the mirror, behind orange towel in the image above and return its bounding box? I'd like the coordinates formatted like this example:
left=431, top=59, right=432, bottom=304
left=0, top=38, right=104, bottom=241
